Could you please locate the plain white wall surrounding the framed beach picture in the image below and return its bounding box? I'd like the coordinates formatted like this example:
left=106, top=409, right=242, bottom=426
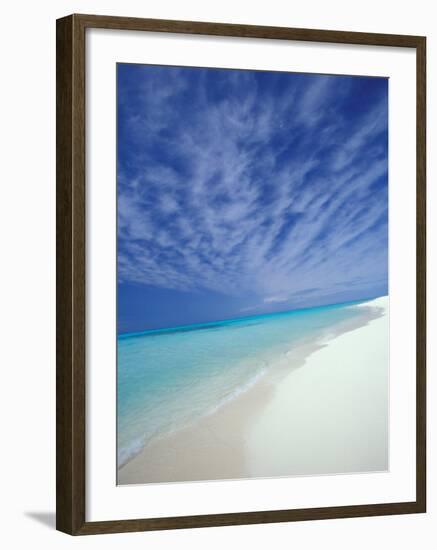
left=0, top=0, right=437, bottom=550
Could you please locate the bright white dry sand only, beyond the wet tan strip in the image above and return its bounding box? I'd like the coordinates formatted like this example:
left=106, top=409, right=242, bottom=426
left=247, top=298, right=388, bottom=477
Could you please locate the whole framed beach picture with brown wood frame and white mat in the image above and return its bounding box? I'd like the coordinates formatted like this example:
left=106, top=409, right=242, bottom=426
left=56, top=15, right=426, bottom=535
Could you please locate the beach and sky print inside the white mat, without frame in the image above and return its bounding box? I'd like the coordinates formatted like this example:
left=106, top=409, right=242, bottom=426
left=117, top=63, right=389, bottom=485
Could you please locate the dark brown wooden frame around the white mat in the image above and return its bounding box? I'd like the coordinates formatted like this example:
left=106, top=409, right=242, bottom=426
left=56, top=15, right=426, bottom=535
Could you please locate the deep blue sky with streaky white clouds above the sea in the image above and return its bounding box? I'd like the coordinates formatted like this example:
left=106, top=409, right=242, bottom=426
left=117, top=64, right=388, bottom=332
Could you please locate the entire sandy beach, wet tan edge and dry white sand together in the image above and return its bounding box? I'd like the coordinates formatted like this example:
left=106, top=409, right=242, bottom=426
left=118, top=297, right=389, bottom=484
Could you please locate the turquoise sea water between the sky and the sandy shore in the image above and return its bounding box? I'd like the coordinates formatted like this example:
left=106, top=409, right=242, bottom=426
left=117, top=302, right=374, bottom=466
